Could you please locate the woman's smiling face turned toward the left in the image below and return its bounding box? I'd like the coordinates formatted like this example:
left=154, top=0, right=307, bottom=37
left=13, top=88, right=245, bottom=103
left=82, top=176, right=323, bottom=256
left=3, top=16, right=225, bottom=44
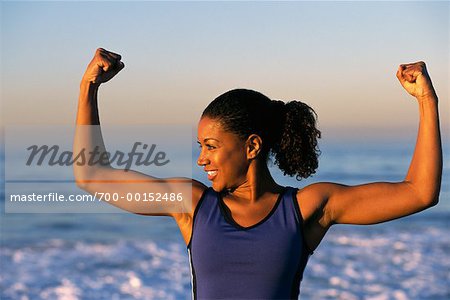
left=197, top=117, right=249, bottom=191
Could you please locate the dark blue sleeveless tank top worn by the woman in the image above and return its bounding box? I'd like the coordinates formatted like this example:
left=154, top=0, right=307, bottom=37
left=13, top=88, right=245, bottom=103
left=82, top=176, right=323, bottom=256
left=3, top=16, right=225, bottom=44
left=188, top=187, right=310, bottom=299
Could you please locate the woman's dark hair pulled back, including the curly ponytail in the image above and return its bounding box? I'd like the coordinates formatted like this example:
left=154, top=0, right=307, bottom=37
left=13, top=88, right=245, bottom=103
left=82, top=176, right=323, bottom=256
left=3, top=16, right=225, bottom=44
left=202, top=89, right=320, bottom=180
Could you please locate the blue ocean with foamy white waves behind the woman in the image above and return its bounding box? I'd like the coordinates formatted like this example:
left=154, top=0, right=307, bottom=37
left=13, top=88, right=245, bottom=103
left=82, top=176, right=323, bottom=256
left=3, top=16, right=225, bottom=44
left=0, top=141, right=450, bottom=300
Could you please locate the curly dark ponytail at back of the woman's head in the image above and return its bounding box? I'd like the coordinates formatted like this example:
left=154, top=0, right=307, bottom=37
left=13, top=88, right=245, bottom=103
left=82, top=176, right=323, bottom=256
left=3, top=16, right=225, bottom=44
left=271, top=101, right=321, bottom=180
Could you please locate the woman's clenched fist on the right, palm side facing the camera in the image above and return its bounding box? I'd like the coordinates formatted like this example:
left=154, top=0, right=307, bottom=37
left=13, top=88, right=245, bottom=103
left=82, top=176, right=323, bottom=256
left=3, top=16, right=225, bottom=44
left=397, top=61, right=436, bottom=100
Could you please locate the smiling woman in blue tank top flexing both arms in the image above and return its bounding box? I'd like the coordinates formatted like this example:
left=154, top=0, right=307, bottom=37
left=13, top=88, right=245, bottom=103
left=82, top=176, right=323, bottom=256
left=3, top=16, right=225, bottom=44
left=74, top=49, right=442, bottom=299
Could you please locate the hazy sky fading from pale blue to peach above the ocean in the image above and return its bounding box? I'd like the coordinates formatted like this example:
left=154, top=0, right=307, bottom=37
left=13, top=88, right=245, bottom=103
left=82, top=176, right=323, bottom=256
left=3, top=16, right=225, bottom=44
left=1, top=1, right=450, bottom=139
